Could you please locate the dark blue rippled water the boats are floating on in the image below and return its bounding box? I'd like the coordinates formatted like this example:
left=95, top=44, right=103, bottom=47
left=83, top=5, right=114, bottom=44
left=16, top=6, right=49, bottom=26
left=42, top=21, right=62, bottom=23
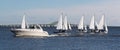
left=0, top=27, right=120, bottom=50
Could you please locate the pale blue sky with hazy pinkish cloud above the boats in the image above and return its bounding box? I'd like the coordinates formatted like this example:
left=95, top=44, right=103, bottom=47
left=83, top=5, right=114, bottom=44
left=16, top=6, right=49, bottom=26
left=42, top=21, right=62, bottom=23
left=0, top=0, right=120, bottom=26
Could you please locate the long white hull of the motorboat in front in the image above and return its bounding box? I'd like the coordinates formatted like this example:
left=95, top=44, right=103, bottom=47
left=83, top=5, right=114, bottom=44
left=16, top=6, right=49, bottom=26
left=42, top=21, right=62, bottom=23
left=11, top=29, right=49, bottom=36
